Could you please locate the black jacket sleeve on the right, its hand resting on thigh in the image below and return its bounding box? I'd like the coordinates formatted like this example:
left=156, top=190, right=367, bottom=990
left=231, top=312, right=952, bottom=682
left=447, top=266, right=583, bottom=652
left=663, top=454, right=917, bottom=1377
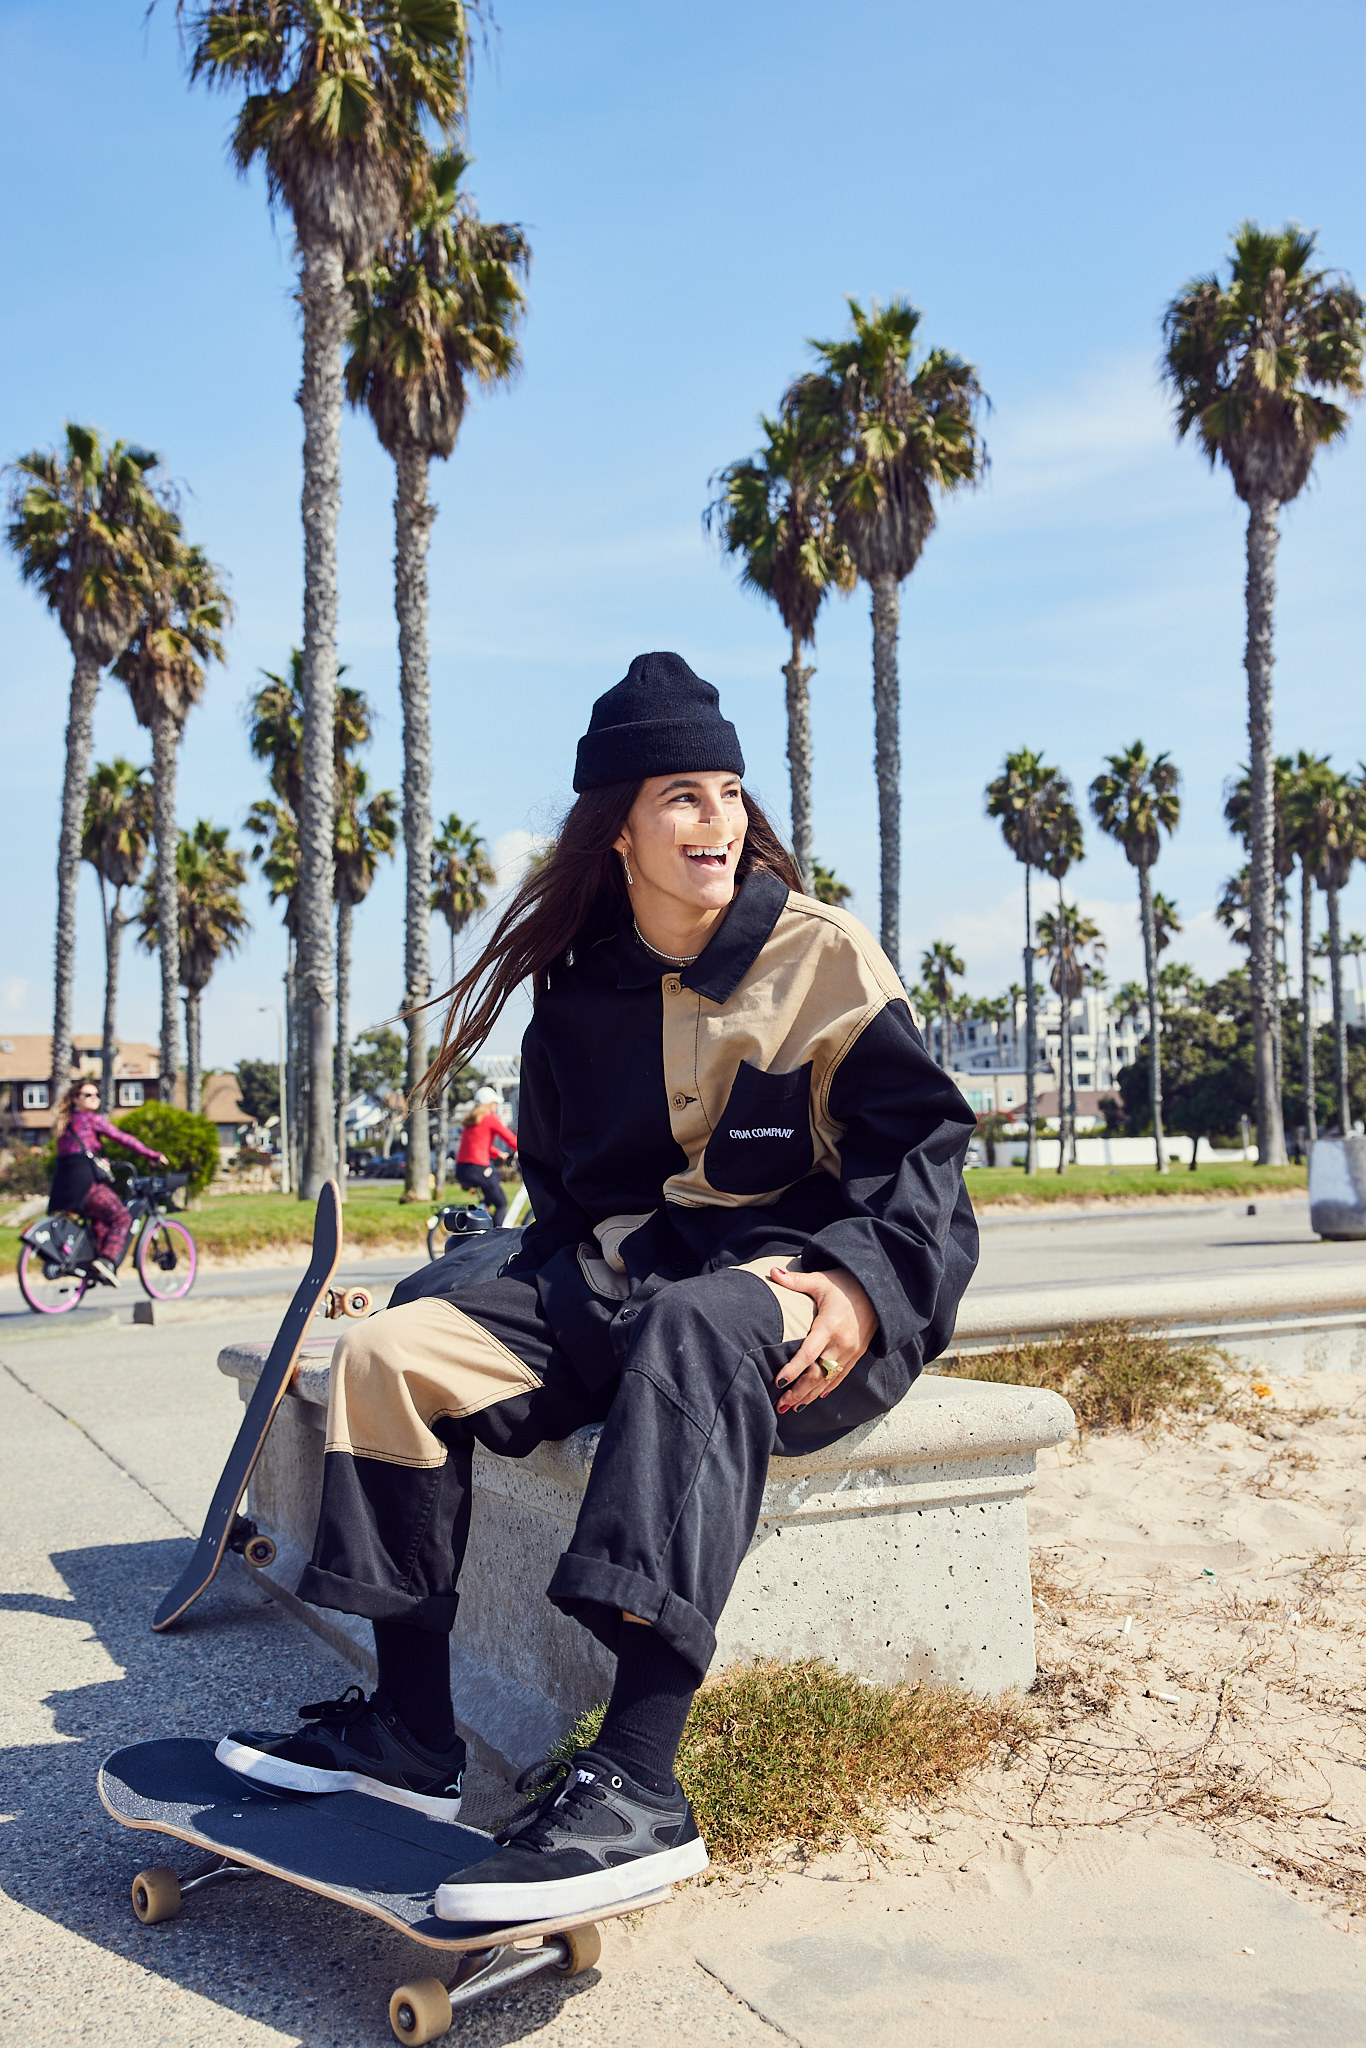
left=803, top=1001, right=977, bottom=1364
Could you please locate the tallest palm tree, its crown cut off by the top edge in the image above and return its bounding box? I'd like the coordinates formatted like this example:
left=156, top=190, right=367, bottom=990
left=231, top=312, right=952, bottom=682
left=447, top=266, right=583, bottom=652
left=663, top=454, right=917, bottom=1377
left=176, top=0, right=467, bottom=1202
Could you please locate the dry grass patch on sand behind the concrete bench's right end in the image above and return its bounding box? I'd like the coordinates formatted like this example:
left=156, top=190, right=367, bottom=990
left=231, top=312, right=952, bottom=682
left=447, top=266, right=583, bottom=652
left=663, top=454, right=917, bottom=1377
left=940, top=1321, right=1231, bottom=1430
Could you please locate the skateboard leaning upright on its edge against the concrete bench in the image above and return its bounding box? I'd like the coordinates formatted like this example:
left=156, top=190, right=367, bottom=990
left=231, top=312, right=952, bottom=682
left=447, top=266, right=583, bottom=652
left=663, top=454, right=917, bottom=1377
left=152, top=1180, right=371, bottom=1634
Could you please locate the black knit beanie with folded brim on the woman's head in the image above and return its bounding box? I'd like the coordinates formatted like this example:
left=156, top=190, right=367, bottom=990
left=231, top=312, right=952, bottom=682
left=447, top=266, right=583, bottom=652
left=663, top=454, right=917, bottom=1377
left=573, top=653, right=745, bottom=791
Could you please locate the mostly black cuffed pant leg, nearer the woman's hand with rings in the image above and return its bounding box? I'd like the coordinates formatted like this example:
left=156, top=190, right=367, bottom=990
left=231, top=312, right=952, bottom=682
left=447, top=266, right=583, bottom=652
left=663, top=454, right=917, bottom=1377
left=549, top=1262, right=811, bottom=1677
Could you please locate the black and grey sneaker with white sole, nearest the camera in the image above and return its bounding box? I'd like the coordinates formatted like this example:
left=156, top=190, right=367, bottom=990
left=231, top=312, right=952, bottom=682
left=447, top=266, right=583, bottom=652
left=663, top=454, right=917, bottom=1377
left=436, top=1749, right=707, bottom=1927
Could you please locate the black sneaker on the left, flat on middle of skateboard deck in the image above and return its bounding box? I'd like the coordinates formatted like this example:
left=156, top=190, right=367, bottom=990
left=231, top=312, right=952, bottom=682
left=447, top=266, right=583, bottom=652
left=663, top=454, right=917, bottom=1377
left=213, top=1686, right=465, bottom=1821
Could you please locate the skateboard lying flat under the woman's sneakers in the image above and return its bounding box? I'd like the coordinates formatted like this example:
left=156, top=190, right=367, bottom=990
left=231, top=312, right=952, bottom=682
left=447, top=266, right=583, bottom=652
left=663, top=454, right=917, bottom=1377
left=98, top=1741, right=670, bottom=2042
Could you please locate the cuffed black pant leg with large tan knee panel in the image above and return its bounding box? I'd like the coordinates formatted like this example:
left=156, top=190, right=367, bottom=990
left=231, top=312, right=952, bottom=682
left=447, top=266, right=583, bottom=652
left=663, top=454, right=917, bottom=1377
left=299, top=1278, right=559, bottom=1630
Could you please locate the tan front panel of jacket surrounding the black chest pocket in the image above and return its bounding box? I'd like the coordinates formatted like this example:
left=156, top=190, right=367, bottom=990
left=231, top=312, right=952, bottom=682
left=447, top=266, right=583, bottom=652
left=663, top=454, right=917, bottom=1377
left=661, top=891, right=905, bottom=1208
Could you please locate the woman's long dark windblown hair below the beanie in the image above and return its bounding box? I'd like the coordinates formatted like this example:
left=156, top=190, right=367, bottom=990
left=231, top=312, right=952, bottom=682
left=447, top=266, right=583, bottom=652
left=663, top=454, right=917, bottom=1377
left=418, top=782, right=803, bottom=1100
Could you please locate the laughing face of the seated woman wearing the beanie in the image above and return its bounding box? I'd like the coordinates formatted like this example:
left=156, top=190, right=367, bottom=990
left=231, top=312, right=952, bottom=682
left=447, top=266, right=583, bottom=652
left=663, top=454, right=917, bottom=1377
left=614, top=770, right=748, bottom=926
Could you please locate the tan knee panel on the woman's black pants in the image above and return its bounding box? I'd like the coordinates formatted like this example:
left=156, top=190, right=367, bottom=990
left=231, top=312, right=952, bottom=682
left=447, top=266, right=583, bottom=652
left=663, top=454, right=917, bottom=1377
left=328, top=1296, right=541, bottom=1468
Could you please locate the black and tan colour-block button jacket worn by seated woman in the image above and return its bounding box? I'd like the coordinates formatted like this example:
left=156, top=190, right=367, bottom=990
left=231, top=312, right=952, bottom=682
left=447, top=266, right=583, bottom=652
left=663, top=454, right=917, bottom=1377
left=512, top=868, right=977, bottom=1440
